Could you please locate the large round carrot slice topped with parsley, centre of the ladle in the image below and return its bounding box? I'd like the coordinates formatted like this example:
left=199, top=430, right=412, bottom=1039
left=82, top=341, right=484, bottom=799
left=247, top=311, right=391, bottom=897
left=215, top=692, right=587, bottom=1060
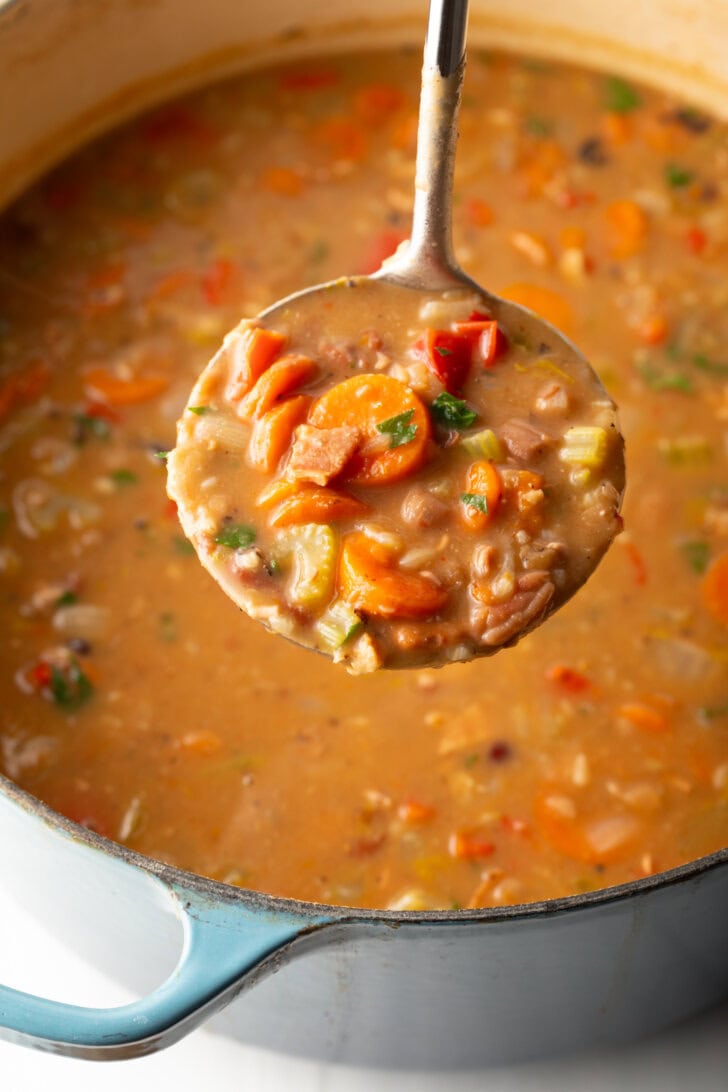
left=309, top=375, right=431, bottom=485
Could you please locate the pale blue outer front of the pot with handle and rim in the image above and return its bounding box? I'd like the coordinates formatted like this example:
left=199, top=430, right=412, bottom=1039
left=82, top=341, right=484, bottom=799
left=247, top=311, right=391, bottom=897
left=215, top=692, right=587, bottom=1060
left=0, top=779, right=728, bottom=1068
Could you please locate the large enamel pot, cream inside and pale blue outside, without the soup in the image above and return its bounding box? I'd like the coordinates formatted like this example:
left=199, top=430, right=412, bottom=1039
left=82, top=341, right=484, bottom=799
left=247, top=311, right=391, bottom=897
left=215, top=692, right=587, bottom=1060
left=0, top=0, right=728, bottom=1067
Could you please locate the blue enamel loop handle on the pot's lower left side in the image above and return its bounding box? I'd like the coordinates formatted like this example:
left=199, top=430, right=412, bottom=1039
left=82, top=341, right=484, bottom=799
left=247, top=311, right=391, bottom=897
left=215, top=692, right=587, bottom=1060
left=0, top=883, right=330, bottom=1059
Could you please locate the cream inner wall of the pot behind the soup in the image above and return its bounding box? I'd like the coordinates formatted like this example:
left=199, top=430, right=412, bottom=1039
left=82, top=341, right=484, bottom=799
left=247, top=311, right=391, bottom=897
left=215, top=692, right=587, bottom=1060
left=0, top=0, right=728, bottom=208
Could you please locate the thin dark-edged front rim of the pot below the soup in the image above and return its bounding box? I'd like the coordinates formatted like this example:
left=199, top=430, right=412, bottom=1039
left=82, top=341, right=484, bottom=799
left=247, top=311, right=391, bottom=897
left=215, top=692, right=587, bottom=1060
left=0, top=773, right=728, bottom=926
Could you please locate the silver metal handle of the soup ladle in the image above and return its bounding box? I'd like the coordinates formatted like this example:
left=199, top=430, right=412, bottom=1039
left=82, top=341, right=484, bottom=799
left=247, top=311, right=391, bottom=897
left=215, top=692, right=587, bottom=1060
left=397, top=0, right=468, bottom=288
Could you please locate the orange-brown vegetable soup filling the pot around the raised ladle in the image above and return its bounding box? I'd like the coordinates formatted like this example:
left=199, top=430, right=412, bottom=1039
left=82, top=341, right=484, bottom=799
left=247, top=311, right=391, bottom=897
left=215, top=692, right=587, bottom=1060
left=0, top=52, right=728, bottom=910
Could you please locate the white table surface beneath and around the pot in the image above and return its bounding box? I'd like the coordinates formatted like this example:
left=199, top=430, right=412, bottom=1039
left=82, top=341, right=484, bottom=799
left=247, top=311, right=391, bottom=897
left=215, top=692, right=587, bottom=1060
left=0, top=890, right=728, bottom=1092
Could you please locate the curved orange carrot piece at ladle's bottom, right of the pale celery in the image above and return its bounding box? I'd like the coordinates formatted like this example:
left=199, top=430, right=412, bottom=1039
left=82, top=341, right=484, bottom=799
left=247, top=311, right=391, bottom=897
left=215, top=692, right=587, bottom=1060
left=338, top=532, right=447, bottom=618
